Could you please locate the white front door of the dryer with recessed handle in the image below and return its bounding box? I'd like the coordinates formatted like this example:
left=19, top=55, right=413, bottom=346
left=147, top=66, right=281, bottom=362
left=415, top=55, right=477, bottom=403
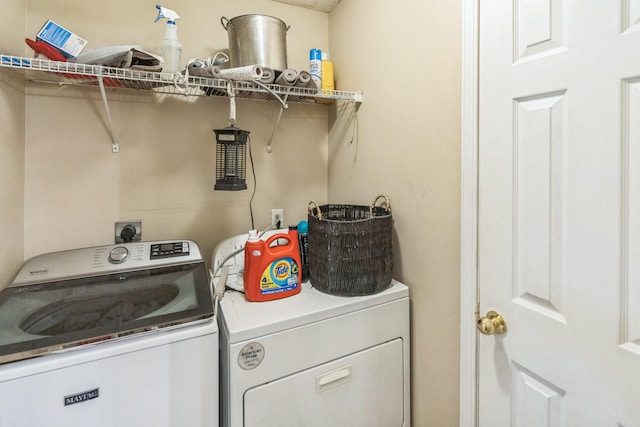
left=244, top=338, right=405, bottom=427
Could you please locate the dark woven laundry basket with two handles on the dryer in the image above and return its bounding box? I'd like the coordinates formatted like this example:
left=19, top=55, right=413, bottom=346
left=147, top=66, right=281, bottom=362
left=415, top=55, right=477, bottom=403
left=308, top=196, right=393, bottom=296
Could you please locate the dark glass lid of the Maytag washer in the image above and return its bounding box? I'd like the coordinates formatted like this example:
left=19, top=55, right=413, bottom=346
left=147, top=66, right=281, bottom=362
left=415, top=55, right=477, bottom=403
left=0, top=262, right=213, bottom=363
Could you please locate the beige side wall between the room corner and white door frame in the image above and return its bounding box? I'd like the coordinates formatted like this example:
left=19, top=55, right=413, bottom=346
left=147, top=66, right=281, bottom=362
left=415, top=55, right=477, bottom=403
left=329, top=0, right=461, bottom=427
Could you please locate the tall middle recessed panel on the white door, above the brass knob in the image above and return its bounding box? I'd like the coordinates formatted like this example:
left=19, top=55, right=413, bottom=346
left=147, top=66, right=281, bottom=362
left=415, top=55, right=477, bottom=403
left=512, top=90, right=567, bottom=322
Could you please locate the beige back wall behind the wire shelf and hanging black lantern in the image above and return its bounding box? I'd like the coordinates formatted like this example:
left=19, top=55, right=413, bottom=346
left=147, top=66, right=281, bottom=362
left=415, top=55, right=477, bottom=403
left=24, top=0, right=328, bottom=264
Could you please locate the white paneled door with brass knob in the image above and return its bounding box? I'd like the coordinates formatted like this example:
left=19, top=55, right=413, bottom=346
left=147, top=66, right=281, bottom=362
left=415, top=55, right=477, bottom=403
left=478, top=0, right=640, bottom=427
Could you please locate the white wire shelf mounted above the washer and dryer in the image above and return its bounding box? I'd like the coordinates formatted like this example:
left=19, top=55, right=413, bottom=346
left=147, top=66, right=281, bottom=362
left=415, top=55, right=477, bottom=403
left=0, top=54, right=362, bottom=103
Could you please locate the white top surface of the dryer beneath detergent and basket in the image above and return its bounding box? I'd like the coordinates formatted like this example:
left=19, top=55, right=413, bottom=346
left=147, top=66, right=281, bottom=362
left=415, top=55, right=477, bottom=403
left=220, top=280, right=409, bottom=343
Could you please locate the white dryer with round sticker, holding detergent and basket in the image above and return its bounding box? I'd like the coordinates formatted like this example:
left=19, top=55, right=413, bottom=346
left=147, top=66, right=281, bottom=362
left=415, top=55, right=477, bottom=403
left=212, top=236, right=410, bottom=427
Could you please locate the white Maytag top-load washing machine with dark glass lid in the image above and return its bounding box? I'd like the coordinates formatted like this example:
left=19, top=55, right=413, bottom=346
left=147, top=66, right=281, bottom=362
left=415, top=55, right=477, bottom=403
left=0, top=240, right=219, bottom=427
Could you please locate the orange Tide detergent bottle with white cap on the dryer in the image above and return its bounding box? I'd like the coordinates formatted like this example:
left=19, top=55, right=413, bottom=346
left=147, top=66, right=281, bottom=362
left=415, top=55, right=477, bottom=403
left=242, top=227, right=302, bottom=302
